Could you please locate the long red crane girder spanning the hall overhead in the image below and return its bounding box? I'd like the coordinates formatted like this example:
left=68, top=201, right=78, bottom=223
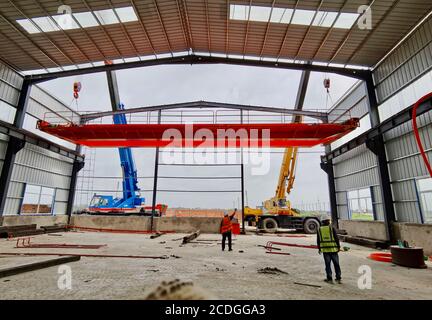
left=38, top=118, right=359, bottom=148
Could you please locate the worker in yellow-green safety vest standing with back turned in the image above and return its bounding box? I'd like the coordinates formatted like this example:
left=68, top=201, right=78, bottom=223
left=317, top=218, right=342, bottom=283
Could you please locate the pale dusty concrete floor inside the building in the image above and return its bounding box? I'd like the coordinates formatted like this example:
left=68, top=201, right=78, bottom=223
left=0, top=232, right=432, bottom=299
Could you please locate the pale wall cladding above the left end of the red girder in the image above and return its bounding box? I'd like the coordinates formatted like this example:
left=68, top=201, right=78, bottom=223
left=27, top=86, right=80, bottom=123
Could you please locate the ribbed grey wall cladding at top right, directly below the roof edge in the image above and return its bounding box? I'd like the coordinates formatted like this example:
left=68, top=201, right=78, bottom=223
left=374, top=17, right=432, bottom=102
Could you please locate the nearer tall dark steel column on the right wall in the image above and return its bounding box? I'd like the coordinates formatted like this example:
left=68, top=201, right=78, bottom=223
left=366, top=73, right=396, bottom=243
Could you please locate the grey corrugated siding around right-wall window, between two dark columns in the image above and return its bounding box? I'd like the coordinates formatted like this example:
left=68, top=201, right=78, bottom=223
left=333, top=145, right=384, bottom=220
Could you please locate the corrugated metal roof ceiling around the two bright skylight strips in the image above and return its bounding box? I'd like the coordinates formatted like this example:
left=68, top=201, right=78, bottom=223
left=0, top=0, right=432, bottom=71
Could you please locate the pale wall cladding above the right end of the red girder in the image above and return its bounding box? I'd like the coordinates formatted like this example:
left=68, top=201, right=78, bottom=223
left=329, top=81, right=368, bottom=122
